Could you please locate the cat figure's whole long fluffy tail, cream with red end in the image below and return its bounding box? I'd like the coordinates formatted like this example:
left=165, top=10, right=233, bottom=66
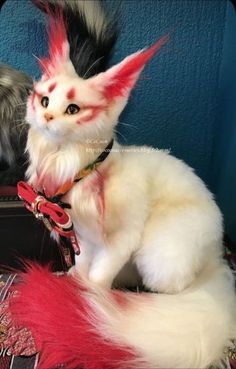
left=10, top=258, right=236, bottom=369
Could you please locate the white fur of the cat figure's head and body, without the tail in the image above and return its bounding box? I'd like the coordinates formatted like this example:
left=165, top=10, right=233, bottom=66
left=27, top=54, right=222, bottom=293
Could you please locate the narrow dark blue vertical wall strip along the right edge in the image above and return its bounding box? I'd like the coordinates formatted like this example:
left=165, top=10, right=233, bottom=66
left=214, top=3, right=236, bottom=244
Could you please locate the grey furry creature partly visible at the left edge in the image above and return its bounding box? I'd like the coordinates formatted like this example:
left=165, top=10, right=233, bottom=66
left=0, top=64, right=33, bottom=185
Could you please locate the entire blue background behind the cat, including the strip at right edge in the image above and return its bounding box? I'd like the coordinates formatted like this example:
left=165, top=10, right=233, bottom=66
left=0, top=0, right=236, bottom=241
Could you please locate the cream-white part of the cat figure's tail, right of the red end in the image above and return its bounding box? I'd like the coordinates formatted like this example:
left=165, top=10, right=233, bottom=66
left=82, top=261, right=236, bottom=369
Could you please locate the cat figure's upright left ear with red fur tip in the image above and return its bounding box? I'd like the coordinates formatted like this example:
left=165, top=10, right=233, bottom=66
left=39, top=8, right=75, bottom=79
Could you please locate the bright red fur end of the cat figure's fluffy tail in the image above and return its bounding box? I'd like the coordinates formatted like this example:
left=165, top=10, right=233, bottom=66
left=10, top=265, right=135, bottom=369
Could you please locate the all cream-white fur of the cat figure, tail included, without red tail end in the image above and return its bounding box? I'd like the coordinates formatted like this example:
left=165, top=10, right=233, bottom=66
left=24, top=30, right=235, bottom=368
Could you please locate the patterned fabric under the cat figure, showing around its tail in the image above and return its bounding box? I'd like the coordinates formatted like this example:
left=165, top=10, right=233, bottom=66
left=0, top=250, right=236, bottom=369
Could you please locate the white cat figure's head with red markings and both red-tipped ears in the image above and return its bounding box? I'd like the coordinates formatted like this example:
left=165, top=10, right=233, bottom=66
left=26, top=11, right=167, bottom=142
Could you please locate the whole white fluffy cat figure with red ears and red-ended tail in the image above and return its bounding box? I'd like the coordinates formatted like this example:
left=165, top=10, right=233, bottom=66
left=11, top=5, right=235, bottom=369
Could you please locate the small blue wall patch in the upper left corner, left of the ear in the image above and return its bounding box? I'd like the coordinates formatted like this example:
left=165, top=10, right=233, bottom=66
left=0, top=0, right=47, bottom=77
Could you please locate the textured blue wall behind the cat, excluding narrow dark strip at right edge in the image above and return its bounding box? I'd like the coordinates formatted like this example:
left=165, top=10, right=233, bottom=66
left=0, top=0, right=226, bottom=183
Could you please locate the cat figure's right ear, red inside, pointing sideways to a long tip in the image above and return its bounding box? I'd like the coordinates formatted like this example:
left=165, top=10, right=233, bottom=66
left=90, top=36, right=168, bottom=100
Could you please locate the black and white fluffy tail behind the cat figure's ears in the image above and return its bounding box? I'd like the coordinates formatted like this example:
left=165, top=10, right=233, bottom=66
left=32, top=0, right=117, bottom=78
